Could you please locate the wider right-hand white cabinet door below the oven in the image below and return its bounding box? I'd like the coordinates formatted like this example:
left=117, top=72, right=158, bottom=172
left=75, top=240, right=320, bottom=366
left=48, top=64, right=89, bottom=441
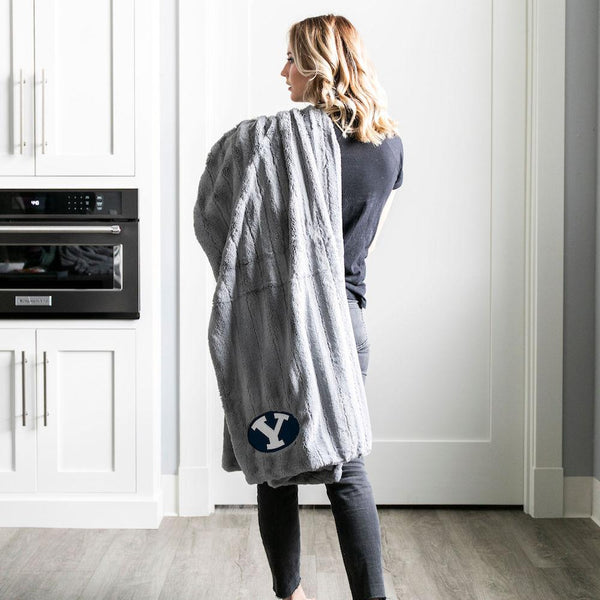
left=36, top=329, right=136, bottom=492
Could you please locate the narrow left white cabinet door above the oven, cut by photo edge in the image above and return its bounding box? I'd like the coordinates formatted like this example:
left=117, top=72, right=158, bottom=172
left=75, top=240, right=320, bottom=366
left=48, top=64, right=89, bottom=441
left=0, top=0, right=35, bottom=176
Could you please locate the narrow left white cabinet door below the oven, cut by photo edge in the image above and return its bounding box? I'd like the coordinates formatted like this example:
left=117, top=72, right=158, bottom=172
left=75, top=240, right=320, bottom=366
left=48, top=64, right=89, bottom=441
left=0, top=329, right=36, bottom=492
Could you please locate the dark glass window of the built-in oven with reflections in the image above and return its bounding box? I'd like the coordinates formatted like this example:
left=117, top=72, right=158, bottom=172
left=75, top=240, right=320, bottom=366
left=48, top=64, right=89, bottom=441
left=0, top=244, right=123, bottom=290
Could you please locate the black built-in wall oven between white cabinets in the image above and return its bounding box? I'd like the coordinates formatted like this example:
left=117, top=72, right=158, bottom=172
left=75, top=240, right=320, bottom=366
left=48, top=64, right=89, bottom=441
left=0, top=189, right=140, bottom=319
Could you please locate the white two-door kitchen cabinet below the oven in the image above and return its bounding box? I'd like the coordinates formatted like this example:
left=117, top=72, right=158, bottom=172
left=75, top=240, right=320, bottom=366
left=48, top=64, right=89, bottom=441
left=0, top=329, right=136, bottom=493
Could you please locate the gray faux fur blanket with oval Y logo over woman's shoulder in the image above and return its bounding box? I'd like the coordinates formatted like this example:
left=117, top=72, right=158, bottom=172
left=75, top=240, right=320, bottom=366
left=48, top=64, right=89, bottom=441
left=194, top=104, right=372, bottom=487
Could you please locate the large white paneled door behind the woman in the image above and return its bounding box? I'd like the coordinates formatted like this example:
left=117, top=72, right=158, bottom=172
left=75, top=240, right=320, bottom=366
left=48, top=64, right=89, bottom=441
left=206, top=0, right=527, bottom=505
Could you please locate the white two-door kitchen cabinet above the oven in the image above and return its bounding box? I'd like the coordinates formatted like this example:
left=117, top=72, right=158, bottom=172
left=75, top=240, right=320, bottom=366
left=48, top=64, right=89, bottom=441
left=0, top=0, right=135, bottom=176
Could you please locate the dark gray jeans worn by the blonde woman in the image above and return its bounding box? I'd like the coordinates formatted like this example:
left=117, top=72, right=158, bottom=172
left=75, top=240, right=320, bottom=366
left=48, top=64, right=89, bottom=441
left=256, top=299, right=385, bottom=600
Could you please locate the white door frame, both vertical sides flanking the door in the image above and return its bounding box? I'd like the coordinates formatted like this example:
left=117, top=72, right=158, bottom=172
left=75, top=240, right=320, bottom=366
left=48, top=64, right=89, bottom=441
left=177, top=0, right=566, bottom=518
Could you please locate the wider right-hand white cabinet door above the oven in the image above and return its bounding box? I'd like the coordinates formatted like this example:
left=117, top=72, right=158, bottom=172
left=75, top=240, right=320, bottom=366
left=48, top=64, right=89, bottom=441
left=34, top=0, right=135, bottom=176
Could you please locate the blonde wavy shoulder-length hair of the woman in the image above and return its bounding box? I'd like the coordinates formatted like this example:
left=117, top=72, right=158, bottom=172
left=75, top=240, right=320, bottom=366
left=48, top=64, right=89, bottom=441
left=288, top=14, right=399, bottom=146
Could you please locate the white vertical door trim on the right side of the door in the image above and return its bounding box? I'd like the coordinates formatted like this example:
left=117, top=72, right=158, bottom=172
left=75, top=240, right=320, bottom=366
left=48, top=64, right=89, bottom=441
left=523, top=0, right=566, bottom=517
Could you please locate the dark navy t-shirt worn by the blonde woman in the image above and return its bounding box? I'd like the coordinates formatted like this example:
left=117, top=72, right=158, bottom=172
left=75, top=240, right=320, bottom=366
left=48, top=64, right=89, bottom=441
left=334, top=124, right=404, bottom=307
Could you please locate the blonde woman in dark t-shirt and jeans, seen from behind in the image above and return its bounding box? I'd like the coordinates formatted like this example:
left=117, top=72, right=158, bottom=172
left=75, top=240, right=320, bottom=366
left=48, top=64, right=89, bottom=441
left=257, top=15, right=403, bottom=600
